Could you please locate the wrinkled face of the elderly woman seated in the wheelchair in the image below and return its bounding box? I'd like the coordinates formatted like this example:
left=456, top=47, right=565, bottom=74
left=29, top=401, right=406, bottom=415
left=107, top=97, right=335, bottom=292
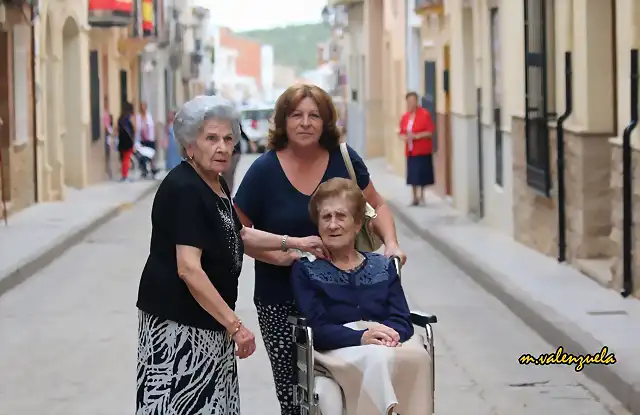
left=318, top=196, right=362, bottom=251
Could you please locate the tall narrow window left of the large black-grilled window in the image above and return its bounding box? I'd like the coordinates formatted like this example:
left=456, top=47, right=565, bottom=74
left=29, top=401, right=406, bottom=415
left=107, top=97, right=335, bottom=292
left=489, top=7, right=504, bottom=187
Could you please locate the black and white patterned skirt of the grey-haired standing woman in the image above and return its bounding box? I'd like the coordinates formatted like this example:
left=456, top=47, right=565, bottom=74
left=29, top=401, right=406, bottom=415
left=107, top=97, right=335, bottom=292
left=136, top=311, right=240, bottom=415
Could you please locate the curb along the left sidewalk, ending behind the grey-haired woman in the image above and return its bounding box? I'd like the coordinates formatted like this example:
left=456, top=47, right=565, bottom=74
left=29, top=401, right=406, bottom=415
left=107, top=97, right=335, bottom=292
left=0, top=181, right=161, bottom=297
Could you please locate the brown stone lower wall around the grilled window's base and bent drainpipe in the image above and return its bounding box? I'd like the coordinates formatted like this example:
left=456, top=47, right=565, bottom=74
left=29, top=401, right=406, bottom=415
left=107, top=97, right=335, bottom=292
left=512, top=118, right=612, bottom=262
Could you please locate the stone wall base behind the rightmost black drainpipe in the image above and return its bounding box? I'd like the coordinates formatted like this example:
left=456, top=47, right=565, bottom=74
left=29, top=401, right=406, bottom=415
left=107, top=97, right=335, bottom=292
left=610, top=145, right=640, bottom=297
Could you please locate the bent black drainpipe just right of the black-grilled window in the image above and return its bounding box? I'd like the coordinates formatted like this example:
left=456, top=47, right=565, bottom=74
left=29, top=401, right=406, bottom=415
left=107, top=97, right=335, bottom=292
left=556, top=52, right=573, bottom=262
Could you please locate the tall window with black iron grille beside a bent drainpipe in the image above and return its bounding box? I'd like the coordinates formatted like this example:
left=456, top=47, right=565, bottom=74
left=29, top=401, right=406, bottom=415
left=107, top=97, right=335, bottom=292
left=524, top=0, right=551, bottom=196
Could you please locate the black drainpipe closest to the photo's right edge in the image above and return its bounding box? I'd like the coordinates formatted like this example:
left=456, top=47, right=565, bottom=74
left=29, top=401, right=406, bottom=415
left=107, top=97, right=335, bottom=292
left=621, top=49, right=639, bottom=298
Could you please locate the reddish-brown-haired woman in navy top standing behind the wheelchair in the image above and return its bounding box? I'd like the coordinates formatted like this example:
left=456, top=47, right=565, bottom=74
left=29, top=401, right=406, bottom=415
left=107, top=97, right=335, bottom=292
left=234, top=84, right=405, bottom=415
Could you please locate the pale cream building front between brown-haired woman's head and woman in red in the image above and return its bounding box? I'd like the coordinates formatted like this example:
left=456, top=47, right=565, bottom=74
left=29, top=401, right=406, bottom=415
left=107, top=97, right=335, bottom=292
left=329, top=0, right=388, bottom=162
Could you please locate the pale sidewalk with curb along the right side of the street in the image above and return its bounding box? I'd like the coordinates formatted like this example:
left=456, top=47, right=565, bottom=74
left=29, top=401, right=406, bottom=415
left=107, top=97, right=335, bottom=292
left=367, top=159, right=640, bottom=414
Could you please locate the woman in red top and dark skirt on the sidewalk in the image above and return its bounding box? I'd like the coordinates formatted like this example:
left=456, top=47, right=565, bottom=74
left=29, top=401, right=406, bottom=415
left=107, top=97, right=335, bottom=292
left=399, top=92, right=435, bottom=206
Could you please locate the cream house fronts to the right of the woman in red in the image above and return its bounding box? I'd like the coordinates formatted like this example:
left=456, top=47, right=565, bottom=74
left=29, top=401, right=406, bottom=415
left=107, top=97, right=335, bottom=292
left=416, top=0, right=640, bottom=295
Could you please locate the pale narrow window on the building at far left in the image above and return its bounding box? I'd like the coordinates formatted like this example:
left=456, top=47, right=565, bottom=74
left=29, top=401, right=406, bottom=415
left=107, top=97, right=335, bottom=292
left=13, top=25, right=31, bottom=145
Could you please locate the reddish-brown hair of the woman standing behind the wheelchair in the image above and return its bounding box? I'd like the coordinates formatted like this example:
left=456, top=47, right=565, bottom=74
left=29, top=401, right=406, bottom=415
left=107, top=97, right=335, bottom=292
left=269, top=84, right=340, bottom=151
